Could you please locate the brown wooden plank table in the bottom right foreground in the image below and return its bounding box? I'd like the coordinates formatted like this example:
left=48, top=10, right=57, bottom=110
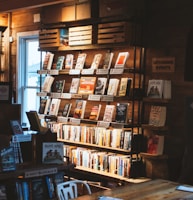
left=76, top=179, right=193, bottom=200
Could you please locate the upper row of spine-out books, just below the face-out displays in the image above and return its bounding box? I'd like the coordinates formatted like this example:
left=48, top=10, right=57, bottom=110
left=55, top=123, right=132, bottom=150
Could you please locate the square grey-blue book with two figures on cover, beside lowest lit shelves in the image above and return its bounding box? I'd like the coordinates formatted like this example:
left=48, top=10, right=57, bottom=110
left=42, top=142, right=64, bottom=164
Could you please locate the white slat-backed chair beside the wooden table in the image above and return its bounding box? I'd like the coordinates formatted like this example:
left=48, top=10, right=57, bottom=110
left=57, top=180, right=91, bottom=200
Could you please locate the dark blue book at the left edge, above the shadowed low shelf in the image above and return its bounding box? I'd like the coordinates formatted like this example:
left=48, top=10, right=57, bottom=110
left=0, top=146, right=16, bottom=172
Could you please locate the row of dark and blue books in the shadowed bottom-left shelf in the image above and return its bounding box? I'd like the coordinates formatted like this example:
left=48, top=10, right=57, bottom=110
left=15, top=172, right=64, bottom=200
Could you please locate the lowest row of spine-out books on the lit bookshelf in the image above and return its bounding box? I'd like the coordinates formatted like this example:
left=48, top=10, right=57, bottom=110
left=64, top=145, right=131, bottom=177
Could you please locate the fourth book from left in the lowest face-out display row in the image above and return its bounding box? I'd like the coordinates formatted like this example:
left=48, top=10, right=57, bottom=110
left=73, top=99, right=87, bottom=119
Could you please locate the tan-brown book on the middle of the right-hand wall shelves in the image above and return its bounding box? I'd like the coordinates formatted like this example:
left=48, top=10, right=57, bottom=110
left=149, top=105, right=167, bottom=126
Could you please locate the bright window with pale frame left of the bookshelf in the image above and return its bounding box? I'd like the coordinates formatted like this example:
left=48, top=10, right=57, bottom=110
left=17, top=31, right=43, bottom=126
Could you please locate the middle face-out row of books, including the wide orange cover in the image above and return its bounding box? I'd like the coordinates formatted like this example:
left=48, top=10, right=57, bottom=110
left=41, top=76, right=132, bottom=96
